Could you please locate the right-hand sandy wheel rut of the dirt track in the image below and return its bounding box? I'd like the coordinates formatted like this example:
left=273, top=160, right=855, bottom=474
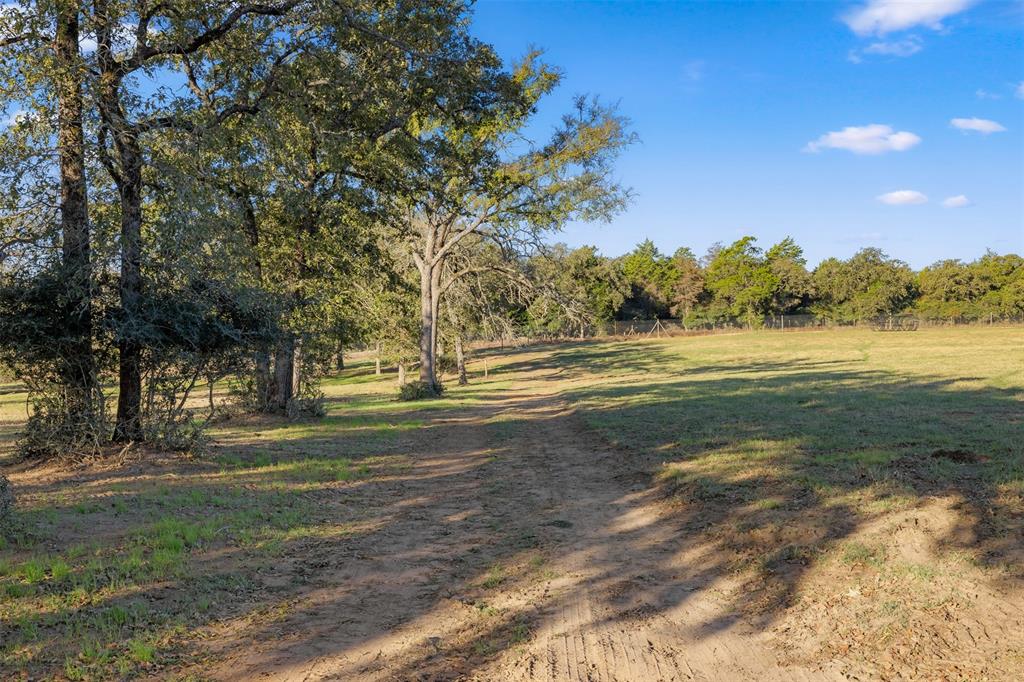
left=474, top=385, right=844, bottom=682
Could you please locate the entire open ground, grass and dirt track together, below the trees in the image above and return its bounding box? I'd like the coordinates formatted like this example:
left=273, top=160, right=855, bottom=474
left=0, top=327, right=1024, bottom=681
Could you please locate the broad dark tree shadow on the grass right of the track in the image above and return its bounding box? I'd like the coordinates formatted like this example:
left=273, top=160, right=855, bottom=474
left=567, top=352, right=1024, bottom=623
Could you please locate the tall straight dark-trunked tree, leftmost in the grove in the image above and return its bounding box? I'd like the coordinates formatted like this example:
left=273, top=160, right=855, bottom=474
left=0, top=0, right=102, bottom=441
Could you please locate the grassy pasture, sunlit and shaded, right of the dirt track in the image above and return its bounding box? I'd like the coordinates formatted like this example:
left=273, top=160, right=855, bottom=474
left=529, top=328, right=1024, bottom=618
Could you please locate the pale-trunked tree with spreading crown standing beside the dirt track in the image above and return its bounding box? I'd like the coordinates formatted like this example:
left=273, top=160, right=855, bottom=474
left=392, top=53, right=630, bottom=391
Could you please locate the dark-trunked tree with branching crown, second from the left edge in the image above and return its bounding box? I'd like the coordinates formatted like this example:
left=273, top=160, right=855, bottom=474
left=0, top=0, right=311, bottom=440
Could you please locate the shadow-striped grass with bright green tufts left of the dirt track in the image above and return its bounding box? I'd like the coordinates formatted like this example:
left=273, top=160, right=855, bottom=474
left=0, top=401, right=512, bottom=677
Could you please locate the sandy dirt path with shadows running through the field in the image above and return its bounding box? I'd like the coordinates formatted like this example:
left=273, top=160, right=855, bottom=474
left=206, top=358, right=847, bottom=681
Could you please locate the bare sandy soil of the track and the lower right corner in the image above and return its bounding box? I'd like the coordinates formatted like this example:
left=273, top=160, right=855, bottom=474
left=163, top=360, right=1024, bottom=681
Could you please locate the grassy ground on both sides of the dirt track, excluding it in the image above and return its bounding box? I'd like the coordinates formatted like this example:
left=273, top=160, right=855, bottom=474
left=0, top=328, right=1024, bottom=680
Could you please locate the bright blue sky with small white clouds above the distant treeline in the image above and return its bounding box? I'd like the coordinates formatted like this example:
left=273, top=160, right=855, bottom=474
left=474, top=0, right=1024, bottom=267
